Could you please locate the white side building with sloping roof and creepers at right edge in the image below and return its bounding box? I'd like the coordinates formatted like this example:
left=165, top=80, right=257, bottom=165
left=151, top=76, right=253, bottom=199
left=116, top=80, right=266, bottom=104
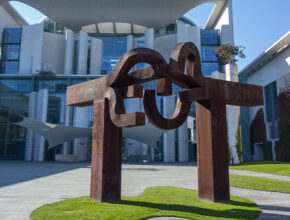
left=239, top=32, right=290, bottom=160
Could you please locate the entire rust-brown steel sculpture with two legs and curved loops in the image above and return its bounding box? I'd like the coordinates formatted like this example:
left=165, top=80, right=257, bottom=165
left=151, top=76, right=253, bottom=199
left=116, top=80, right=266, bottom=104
left=66, top=43, right=263, bottom=202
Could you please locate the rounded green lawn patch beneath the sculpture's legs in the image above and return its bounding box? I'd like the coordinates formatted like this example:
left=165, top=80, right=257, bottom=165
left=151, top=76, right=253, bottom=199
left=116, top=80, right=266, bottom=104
left=30, top=187, right=260, bottom=220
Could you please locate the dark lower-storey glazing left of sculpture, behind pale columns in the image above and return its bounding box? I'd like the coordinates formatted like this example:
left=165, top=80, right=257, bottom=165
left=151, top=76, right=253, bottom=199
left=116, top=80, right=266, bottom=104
left=0, top=76, right=96, bottom=160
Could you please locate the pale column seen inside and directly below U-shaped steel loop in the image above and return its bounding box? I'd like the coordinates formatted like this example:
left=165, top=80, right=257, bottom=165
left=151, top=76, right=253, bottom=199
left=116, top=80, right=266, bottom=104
left=163, top=95, right=175, bottom=162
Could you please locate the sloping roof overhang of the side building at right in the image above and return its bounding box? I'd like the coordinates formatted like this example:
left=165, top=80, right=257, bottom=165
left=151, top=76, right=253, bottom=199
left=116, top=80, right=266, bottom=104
left=239, top=31, right=290, bottom=78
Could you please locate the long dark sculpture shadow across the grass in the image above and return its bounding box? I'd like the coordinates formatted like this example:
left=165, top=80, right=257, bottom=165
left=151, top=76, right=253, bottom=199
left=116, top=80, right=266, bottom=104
left=115, top=200, right=260, bottom=219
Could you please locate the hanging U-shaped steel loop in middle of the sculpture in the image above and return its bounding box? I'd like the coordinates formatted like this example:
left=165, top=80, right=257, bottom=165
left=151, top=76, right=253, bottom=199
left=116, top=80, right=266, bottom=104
left=143, top=90, right=191, bottom=129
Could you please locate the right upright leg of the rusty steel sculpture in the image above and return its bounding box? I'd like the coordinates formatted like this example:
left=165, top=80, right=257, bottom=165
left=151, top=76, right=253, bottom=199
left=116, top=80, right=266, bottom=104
left=196, top=100, right=230, bottom=202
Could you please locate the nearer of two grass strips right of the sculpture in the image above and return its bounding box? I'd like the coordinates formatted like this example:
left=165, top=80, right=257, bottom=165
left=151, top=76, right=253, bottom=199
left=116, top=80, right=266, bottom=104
left=230, top=174, right=290, bottom=193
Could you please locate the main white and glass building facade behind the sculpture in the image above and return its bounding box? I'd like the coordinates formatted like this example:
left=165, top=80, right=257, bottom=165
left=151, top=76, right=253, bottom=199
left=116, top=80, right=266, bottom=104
left=0, top=0, right=239, bottom=162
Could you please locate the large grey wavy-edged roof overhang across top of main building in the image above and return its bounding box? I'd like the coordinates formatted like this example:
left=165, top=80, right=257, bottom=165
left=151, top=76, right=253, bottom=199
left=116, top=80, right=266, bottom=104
left=0, top=0, right=227, bottom=31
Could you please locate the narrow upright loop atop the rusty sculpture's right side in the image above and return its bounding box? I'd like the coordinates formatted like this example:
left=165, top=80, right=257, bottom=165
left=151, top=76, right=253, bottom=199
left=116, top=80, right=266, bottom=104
left=169, top=42, right=204, bottom=88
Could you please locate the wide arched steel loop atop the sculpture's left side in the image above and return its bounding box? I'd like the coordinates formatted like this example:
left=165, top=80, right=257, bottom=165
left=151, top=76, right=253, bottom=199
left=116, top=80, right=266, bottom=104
left=107, top=48, right=167, bottom=87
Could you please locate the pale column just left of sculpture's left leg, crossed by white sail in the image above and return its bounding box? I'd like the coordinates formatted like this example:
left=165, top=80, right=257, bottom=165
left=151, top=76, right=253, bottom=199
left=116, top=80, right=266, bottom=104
left=74, top=107, right=89, bottom=161
